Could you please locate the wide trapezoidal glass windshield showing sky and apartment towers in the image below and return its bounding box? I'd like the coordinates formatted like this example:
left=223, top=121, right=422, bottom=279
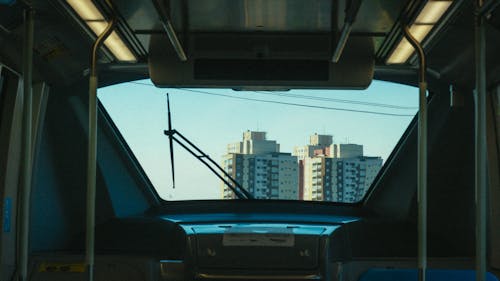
left=99, top=80, right=418, bottom=203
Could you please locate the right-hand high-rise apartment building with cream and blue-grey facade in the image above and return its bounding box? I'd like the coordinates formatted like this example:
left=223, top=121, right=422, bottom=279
left=294, top=135, right=382, bottom=202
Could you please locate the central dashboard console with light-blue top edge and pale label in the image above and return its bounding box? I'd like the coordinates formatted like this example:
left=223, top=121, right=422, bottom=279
left=171, top=223, right=340, bottom=280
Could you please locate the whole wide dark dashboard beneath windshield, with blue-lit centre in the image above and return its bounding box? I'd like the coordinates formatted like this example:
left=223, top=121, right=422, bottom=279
left=35, top=200, right=470, bottom=281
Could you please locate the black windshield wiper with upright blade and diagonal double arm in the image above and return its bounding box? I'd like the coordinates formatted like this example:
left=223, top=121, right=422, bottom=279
left=163, top=93, right=253, bottom=199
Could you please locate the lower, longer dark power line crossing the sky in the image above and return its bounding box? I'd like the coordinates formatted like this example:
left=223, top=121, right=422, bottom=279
left=129, top=82, right=413, bottom=117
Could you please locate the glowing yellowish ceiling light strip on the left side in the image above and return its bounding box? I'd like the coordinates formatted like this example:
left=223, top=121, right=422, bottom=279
left=66, top=0, right=137, bottom=62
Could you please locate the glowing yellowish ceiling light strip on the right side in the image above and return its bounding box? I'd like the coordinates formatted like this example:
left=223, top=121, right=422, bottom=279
left=387, top=0, right=453, bottom=64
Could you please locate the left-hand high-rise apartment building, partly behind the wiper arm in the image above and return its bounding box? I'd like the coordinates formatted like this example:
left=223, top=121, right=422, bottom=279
left=222, top=131, right=299, bottom=199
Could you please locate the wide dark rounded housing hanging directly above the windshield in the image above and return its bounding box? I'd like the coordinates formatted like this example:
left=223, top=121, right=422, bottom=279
left=149, top=34, right=374, bottom=90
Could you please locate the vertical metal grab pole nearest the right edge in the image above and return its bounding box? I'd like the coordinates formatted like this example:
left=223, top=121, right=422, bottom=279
left=474, top=0, right=487, bottom=281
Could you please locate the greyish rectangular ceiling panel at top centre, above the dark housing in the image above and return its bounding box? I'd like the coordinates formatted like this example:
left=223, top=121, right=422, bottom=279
left=187, top=0, right=332, bottom=32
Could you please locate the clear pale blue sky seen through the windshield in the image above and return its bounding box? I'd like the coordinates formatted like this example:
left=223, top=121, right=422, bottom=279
left=99, top=80, right=418, bottom=200
